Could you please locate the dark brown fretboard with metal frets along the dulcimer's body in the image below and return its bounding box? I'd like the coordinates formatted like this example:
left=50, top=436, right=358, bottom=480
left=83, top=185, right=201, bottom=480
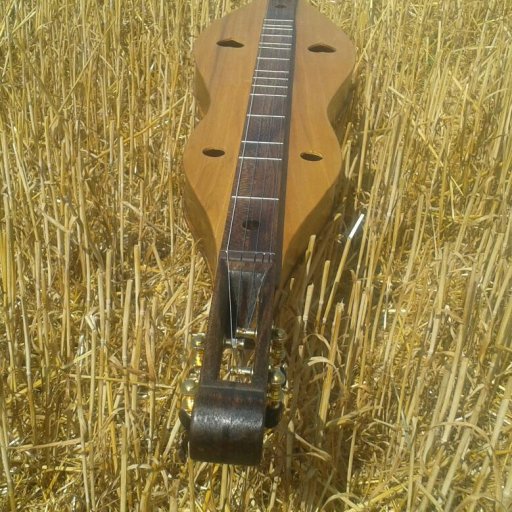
left=222, top=0, right=296, bottom=266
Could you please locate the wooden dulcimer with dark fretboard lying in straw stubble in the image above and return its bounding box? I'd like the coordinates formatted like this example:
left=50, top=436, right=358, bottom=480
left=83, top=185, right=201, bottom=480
left=180, top=0, right=355, bottom=465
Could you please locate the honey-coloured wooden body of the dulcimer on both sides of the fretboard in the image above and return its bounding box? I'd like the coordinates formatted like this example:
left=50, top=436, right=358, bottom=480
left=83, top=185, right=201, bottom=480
left=184, top=0, right=354, bottom=280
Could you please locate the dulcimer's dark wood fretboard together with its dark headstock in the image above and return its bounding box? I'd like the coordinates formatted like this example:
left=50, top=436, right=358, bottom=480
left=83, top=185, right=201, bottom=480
left=189, top=0, right=296, bottom=464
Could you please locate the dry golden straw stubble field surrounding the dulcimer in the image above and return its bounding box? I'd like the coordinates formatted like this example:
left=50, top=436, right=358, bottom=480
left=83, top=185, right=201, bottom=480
left=0, top=0, right=512, bottom=511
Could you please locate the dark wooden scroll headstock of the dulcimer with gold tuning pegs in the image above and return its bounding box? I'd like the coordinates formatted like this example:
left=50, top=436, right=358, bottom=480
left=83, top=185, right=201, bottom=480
left=180, top=261, right=285, bottom=465
